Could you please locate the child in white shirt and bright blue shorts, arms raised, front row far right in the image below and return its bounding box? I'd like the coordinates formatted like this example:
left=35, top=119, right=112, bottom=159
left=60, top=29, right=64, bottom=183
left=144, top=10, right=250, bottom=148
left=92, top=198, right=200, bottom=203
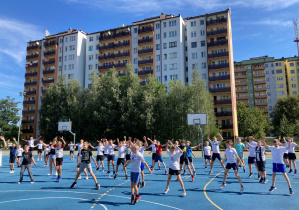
left=263, top=139, right=294, bottom=194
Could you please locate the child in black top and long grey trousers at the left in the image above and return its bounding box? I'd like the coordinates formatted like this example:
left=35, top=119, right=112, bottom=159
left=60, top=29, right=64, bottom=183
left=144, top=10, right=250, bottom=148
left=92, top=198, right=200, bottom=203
left=18, top=145, right=36, bottom=184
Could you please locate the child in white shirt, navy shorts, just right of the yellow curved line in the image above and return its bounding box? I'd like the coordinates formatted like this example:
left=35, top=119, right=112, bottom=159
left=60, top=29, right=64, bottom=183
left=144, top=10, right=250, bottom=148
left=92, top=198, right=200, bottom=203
left=219, top=141, right=245, bottom=193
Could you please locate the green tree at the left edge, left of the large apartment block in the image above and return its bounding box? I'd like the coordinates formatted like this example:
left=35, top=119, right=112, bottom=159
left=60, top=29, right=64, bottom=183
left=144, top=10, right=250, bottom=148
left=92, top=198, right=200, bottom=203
left=0, top=96, right=20, bottom=139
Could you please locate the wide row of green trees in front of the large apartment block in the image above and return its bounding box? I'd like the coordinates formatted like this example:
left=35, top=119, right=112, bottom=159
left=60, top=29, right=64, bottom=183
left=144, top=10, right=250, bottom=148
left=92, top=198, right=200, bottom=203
left=40, top=64, right=218, bottom=144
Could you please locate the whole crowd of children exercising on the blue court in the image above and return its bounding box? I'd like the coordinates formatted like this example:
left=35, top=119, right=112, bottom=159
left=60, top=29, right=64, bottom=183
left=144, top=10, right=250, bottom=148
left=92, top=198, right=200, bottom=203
left=0, top=132, right=298, bottom=204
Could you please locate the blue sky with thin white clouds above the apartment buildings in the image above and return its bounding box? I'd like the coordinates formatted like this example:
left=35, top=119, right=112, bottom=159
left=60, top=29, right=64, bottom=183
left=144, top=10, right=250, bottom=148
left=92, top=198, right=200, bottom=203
left=0, top=0, right=299, bottom=104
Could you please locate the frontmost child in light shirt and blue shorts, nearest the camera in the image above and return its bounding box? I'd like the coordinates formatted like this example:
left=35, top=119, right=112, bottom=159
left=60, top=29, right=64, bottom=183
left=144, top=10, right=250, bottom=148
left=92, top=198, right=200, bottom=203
left=125, top=144, right=152, bottom=205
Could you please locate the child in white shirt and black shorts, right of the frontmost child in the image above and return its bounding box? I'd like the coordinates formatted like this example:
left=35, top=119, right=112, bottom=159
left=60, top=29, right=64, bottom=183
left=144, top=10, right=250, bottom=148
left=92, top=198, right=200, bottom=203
left=164, top=141, right=186, bottom=196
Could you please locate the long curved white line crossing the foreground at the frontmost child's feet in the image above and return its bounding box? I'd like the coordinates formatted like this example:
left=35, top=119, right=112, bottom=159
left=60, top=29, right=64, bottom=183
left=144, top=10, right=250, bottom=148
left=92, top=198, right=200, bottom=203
left=0, top=190, right=182, bottom=210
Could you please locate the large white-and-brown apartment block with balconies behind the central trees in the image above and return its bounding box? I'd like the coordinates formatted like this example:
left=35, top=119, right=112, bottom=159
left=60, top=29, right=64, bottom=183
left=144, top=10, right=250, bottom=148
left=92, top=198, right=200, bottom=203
left=23, top=9, right=238, bottom=137
